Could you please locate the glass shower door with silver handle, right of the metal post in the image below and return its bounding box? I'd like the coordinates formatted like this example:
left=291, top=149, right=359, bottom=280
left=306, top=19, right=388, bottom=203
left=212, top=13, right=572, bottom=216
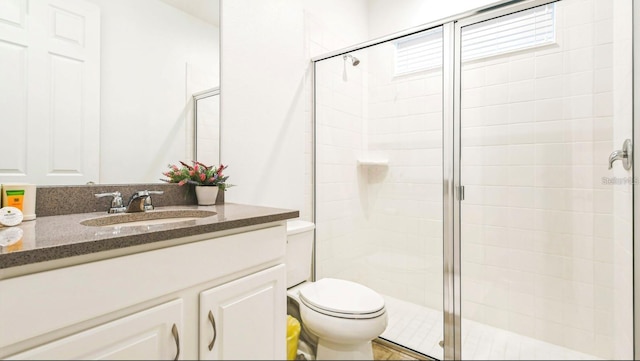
left=456, top=0, right=633, bottom=360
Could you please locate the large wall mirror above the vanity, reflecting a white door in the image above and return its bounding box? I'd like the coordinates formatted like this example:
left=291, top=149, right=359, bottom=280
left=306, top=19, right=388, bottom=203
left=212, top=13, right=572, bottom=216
left=0, top=0, right=220, bottom=185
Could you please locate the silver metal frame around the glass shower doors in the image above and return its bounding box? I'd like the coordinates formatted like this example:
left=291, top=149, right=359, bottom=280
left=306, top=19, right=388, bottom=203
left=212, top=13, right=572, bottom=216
left=310, top=0, right=640, bottom=360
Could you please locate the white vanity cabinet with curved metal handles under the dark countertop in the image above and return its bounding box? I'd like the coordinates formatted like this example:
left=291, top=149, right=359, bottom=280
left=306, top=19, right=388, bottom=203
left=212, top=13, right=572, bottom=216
left=0, top=223, right=286, bottom=360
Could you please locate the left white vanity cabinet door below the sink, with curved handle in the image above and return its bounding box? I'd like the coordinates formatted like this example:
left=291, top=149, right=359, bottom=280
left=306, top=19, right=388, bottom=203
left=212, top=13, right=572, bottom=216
left=8, top=299, right=183, bottom=360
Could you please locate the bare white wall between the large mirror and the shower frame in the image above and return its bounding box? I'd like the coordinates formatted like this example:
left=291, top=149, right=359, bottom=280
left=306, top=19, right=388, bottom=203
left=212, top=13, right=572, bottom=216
left=221, top=0, right=366, bottom=215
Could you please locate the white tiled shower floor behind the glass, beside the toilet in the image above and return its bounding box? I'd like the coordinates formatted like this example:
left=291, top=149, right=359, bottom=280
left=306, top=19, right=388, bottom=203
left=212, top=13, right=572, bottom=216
left=380, top=295, right=601, bottom=360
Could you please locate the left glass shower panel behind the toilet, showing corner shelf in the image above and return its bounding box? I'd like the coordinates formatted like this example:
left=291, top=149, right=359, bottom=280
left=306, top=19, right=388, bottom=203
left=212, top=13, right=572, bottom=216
left=315, top=24, right=443, bottom=359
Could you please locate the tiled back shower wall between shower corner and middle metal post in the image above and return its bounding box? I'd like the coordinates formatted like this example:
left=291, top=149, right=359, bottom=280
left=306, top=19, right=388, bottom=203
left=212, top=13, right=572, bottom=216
left=359, top=42, right=443, bottom=310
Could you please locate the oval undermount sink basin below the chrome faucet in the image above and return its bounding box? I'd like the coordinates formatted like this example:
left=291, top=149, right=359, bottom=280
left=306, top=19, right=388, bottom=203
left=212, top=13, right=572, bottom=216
left=80, top=209, right=217, bottom=227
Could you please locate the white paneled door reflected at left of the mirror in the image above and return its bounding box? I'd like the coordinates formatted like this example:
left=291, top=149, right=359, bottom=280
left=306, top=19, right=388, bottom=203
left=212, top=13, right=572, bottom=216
left=0, top=0, right=100, bottom=184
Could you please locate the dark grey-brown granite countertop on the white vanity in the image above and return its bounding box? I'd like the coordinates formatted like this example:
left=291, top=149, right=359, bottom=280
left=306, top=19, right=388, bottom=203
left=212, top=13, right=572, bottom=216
left=0, top=203, right=299, bottom=269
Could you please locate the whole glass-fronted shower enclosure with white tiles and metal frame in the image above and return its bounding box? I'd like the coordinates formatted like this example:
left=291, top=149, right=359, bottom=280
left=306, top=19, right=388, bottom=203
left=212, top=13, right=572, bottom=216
left=314, top=0, right=634, bottom=360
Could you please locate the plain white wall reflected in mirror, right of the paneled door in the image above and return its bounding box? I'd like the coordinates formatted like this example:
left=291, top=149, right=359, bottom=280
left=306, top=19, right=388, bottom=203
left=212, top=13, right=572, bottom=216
left=89, top=0, right=219, bottom=184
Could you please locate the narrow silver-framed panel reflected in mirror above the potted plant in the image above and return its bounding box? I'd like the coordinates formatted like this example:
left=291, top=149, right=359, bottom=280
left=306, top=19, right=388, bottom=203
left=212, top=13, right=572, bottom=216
left=193, top=87, right=220, bottom=165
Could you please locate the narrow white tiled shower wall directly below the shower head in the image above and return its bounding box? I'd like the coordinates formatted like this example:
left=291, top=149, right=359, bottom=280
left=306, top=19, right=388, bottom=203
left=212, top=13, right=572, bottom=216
left=315, top=49, right=367, bottom=281
